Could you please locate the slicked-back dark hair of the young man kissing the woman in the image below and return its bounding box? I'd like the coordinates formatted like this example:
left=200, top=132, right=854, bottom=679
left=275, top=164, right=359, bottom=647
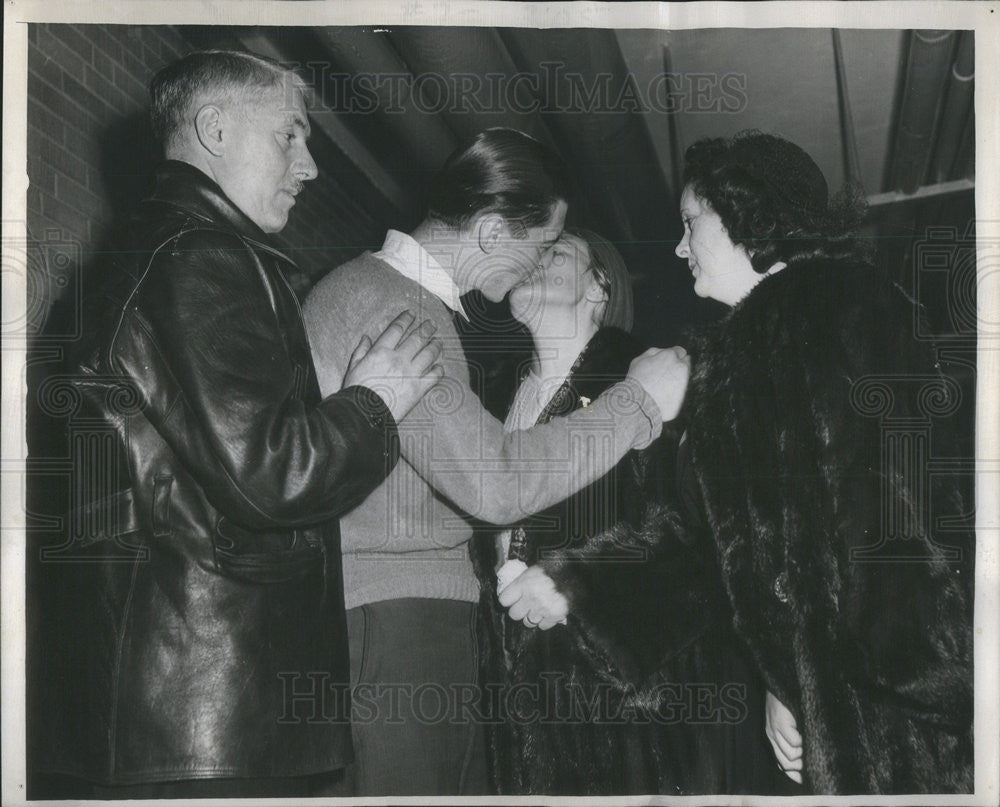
left=427, top=128, right=571, bottom=227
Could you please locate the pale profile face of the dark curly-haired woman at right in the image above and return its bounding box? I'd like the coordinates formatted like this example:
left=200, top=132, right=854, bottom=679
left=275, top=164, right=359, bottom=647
left=674, top=185, right=763, bottom=306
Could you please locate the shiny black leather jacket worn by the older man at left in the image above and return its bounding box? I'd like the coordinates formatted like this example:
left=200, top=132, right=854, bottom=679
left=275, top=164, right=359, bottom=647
left=29, top=162, right=397, bottom=784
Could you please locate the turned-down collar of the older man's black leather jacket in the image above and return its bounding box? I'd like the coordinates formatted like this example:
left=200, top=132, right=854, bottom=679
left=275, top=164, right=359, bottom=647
left=148, top=160, right=295, bottom=266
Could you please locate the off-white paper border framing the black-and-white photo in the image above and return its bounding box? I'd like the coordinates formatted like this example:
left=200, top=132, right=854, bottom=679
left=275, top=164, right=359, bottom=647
left=0, top=0, right=1000, bottom=805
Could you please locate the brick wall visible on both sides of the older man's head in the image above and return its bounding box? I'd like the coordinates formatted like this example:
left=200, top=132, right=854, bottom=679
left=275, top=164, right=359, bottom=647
left=27, top=24, right=394, bottom=317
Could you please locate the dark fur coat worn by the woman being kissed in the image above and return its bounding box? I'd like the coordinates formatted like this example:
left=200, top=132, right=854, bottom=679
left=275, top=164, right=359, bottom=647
left=472, top=329, right=773, bottom=795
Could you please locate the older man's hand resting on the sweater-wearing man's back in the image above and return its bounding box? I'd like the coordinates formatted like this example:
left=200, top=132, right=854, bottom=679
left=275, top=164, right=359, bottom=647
left=343, top=311, right=444, bottom=423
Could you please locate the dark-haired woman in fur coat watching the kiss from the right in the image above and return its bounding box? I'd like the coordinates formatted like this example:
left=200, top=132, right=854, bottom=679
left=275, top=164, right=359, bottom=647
left=677, top=132, right=974, bottom=794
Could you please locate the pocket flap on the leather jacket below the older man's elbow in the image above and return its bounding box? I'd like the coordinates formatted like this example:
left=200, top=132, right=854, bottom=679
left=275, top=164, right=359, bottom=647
left=214, top=517, right=324, bottom=583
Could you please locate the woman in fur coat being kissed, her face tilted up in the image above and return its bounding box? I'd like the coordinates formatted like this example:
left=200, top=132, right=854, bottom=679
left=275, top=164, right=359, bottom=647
left=472, top=229, right=780, bottom=795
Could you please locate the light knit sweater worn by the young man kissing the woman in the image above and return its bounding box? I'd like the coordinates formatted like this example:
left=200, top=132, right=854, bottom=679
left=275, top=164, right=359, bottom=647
left=304, top=252, right=661, bottom=608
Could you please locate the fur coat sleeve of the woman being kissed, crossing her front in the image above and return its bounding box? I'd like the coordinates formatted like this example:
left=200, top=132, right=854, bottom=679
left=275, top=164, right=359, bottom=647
left=478, top=329, right=726, bottom=689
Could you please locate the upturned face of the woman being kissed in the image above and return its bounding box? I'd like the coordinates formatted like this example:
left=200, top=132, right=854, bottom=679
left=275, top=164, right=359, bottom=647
left=510, top=233, right=596, bottom=327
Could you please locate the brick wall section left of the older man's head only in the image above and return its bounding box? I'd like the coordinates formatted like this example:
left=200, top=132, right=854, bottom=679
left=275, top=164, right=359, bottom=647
left=27, top=24, right=190, bottom=328
